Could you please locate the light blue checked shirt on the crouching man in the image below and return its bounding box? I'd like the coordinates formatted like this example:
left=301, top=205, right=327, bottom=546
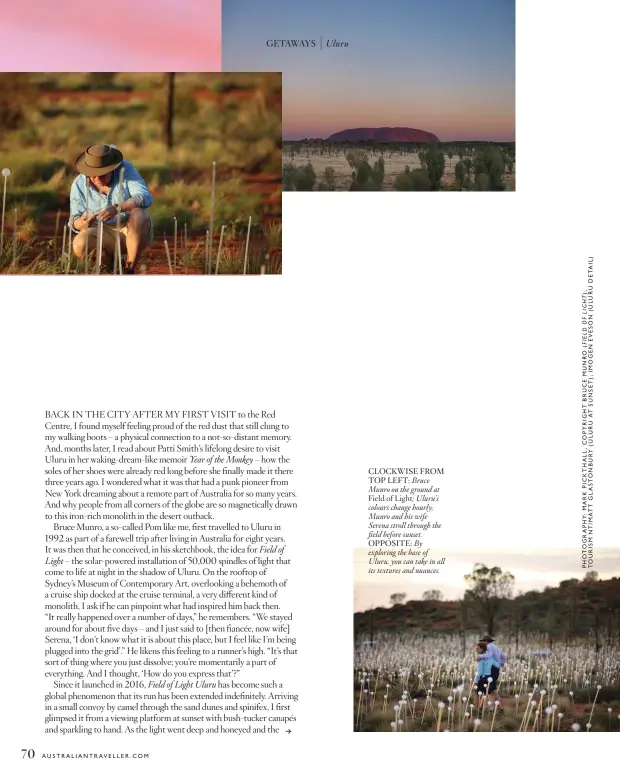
left=70, top=160, right=153, bottom=230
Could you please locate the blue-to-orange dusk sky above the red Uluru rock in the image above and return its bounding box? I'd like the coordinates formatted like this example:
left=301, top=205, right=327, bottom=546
left=222, top=0, right=515, bottom=141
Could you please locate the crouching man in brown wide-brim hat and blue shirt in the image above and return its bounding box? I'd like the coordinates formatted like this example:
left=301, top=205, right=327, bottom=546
left=70, top=144, right=153, bottom=273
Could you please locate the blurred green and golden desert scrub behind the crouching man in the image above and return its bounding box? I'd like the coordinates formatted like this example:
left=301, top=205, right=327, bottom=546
left=0, top=73, right=282, bottom=273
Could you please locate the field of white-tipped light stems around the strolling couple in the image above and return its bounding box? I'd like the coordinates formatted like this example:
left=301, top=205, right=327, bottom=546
left=353, top=634, right=620, bottom=733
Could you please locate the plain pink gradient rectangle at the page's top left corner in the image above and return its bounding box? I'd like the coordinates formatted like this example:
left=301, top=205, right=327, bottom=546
left=0, top=0, right=222, bottom=73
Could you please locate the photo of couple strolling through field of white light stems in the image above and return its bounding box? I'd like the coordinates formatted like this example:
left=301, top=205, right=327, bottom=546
left=353, top=549, right=620, bottom=733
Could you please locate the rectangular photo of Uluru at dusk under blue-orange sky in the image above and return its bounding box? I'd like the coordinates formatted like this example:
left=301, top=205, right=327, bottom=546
left=222, top=0, right=516, bottom=191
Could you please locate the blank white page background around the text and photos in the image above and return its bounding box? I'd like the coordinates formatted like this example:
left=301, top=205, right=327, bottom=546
left=0, top=1, right=620, bottom=778
